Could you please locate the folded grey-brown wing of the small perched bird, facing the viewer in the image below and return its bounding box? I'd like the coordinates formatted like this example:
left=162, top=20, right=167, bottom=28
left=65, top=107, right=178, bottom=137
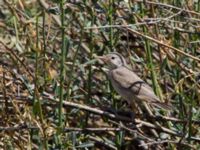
left=112, top=67, right=159, bottom=102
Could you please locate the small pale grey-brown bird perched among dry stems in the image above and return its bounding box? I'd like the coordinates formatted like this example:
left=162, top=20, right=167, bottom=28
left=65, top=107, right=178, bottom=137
left=98, top=52, right=172, bottom=110
